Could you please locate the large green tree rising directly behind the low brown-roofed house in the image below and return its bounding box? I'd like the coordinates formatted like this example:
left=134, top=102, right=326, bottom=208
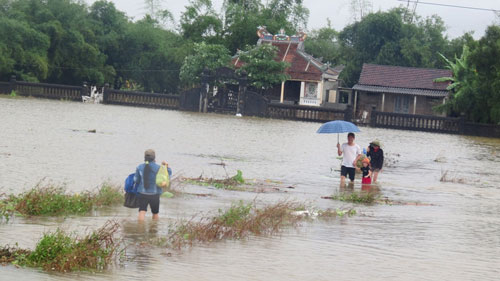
left=338, top=8, right=449, bottom=86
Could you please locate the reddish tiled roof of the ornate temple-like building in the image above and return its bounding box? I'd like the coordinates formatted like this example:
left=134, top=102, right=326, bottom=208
left=232, top=40, right=342, bottom=81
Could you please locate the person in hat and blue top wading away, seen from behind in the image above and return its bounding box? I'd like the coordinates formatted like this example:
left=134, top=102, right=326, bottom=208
left=134, top=149, right=167, bottom=221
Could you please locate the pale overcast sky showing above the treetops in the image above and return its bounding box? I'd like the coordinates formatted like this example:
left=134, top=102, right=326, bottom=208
left=86, top=0, right=500, bottom=39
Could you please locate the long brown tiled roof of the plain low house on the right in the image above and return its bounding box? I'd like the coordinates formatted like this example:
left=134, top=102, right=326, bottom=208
left=358, top=63, right=452, bottom=90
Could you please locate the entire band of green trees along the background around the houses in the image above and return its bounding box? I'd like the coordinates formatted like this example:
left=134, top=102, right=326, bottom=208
left=0, top=0, right=500, bottom=124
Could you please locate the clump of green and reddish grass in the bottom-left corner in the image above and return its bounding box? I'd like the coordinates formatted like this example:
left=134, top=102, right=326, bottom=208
left=0, top=222, right=120, bottom=272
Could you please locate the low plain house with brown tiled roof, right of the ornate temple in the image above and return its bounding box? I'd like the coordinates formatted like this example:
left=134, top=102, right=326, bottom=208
left=352, top=63, right=452, bottom=117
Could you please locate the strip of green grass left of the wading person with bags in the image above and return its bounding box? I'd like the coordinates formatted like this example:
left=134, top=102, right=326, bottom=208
left=0, top=180, right=123, bottom=220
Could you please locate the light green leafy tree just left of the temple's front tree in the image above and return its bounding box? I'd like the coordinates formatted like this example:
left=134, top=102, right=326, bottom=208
left=179, top=42, right=231, bottom=87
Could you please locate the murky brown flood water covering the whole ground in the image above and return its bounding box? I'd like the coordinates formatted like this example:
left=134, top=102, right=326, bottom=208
left=0, top=95, right=500, bottom=280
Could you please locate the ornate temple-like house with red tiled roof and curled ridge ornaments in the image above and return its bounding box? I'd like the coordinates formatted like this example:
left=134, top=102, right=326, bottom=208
left=232, top=27, right=343, bottom=106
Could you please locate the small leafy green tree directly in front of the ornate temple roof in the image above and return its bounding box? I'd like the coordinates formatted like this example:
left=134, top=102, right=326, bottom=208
left=239, top=44, right=289, bottom=90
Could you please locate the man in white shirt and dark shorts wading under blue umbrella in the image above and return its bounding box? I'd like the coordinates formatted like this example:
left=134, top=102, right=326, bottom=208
left=337, top=133, right=361, bottom=186
